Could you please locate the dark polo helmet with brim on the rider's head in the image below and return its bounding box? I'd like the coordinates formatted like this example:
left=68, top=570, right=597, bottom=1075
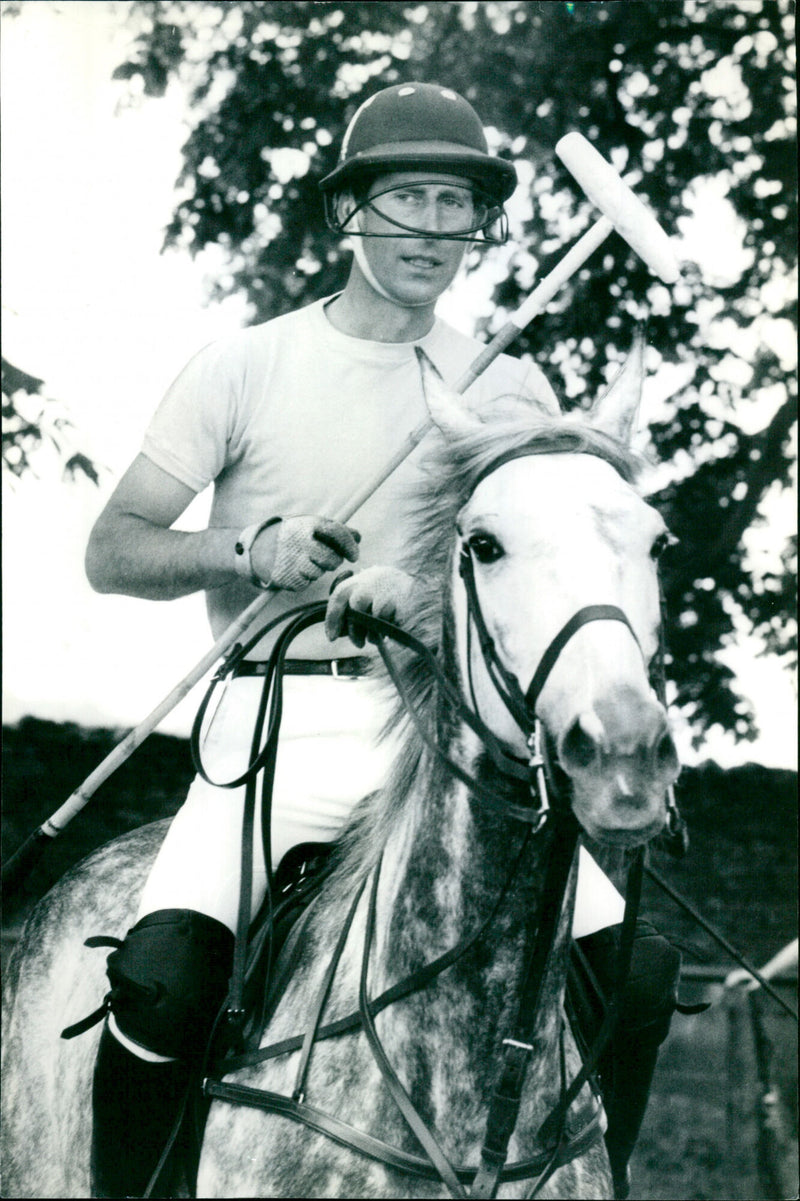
left=320, top=83, right=517, bottom=241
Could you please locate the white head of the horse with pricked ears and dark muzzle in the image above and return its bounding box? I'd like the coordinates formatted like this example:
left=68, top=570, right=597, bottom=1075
left=425, top=346, right=679, bottom=847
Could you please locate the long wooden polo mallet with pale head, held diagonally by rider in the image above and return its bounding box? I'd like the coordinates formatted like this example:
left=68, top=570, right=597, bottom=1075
left=2, top=133, right=680, bottom=892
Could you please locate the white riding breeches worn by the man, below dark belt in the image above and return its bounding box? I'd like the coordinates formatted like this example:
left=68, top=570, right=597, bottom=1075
left=137, top=676, right=623, bottom=937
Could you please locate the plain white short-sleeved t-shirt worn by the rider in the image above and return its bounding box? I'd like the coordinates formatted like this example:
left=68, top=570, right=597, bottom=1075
left=142, top=298, right=555, bottom=658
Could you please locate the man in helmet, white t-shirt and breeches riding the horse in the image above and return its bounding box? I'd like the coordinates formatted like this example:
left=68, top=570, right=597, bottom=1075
left=86, top=83, right=677, bottom=1196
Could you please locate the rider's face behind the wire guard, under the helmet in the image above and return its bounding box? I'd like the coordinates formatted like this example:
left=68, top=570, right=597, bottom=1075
left=357, top=172, right=474, bottom=305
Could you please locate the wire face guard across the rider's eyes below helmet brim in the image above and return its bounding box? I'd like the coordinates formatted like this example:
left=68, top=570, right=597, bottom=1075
left=324, top=175, right=508, bottom=246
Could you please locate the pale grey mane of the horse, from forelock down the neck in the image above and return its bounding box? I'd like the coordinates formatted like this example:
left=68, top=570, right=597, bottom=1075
left=321, top=408, right=643, bottom=889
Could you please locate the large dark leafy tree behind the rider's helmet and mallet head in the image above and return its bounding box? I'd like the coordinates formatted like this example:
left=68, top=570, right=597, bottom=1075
left=110, top=0, right=796, bottom=740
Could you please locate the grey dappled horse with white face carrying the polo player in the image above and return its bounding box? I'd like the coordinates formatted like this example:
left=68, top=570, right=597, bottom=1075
left=2, top=347, right=677, bottom=1197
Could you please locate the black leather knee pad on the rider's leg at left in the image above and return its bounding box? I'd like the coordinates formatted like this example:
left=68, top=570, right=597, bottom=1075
left=107, top=909, right=234, bottom=1059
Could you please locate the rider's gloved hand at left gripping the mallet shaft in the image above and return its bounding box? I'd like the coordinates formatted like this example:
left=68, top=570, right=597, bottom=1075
left=250, top=516, right=362, bottom=591
